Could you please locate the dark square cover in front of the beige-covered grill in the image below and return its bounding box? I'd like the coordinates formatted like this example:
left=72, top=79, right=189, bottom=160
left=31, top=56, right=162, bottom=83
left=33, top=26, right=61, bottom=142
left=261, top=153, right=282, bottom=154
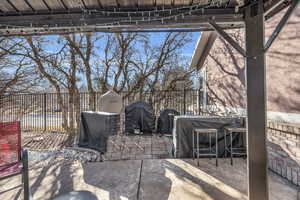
left=78, top=112, right=120, bottom=153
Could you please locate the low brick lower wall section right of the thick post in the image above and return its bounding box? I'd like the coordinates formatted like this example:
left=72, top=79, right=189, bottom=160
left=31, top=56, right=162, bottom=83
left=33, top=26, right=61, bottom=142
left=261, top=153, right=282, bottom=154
left=267, top=121, right=300, bottom=186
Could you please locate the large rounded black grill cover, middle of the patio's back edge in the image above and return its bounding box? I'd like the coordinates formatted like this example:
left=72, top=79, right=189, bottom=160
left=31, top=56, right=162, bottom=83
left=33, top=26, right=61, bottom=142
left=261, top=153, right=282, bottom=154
left=125, top=101, right=155, bottom=134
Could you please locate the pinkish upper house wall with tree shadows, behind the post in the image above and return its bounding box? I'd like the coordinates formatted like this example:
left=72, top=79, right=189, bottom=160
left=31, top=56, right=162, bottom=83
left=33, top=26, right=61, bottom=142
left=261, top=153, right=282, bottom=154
left=206, top=6, right=300, bottom=114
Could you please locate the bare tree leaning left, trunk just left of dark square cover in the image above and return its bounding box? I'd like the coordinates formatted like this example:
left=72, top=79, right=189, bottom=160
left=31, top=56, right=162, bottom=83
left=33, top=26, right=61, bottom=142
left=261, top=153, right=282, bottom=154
left=1, top=35, right=81, bottom=141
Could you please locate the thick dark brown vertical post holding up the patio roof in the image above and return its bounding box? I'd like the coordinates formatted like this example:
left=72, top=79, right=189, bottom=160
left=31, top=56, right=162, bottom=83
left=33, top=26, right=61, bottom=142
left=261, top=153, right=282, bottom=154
left=245, top=0, right=268, bottom=200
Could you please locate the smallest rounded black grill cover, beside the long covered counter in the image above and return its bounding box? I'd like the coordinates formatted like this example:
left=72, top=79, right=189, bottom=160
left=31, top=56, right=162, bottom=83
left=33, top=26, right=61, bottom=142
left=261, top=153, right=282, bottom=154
left=157, top=108, right=180, bottom=134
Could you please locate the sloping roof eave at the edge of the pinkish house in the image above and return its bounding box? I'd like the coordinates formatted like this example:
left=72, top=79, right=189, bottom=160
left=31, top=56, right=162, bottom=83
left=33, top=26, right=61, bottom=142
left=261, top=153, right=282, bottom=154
left=190, top=31, right=218, bottom=70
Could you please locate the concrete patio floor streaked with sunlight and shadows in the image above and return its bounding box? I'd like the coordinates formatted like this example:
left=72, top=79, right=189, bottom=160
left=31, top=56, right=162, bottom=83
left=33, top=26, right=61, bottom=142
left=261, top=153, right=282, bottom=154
left=0, top=159, right=299, bottom=200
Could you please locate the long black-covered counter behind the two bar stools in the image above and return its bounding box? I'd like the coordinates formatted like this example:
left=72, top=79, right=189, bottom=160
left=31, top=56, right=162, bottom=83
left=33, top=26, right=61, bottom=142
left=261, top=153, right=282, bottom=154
left=172, top=115, right=245, bottom=158
